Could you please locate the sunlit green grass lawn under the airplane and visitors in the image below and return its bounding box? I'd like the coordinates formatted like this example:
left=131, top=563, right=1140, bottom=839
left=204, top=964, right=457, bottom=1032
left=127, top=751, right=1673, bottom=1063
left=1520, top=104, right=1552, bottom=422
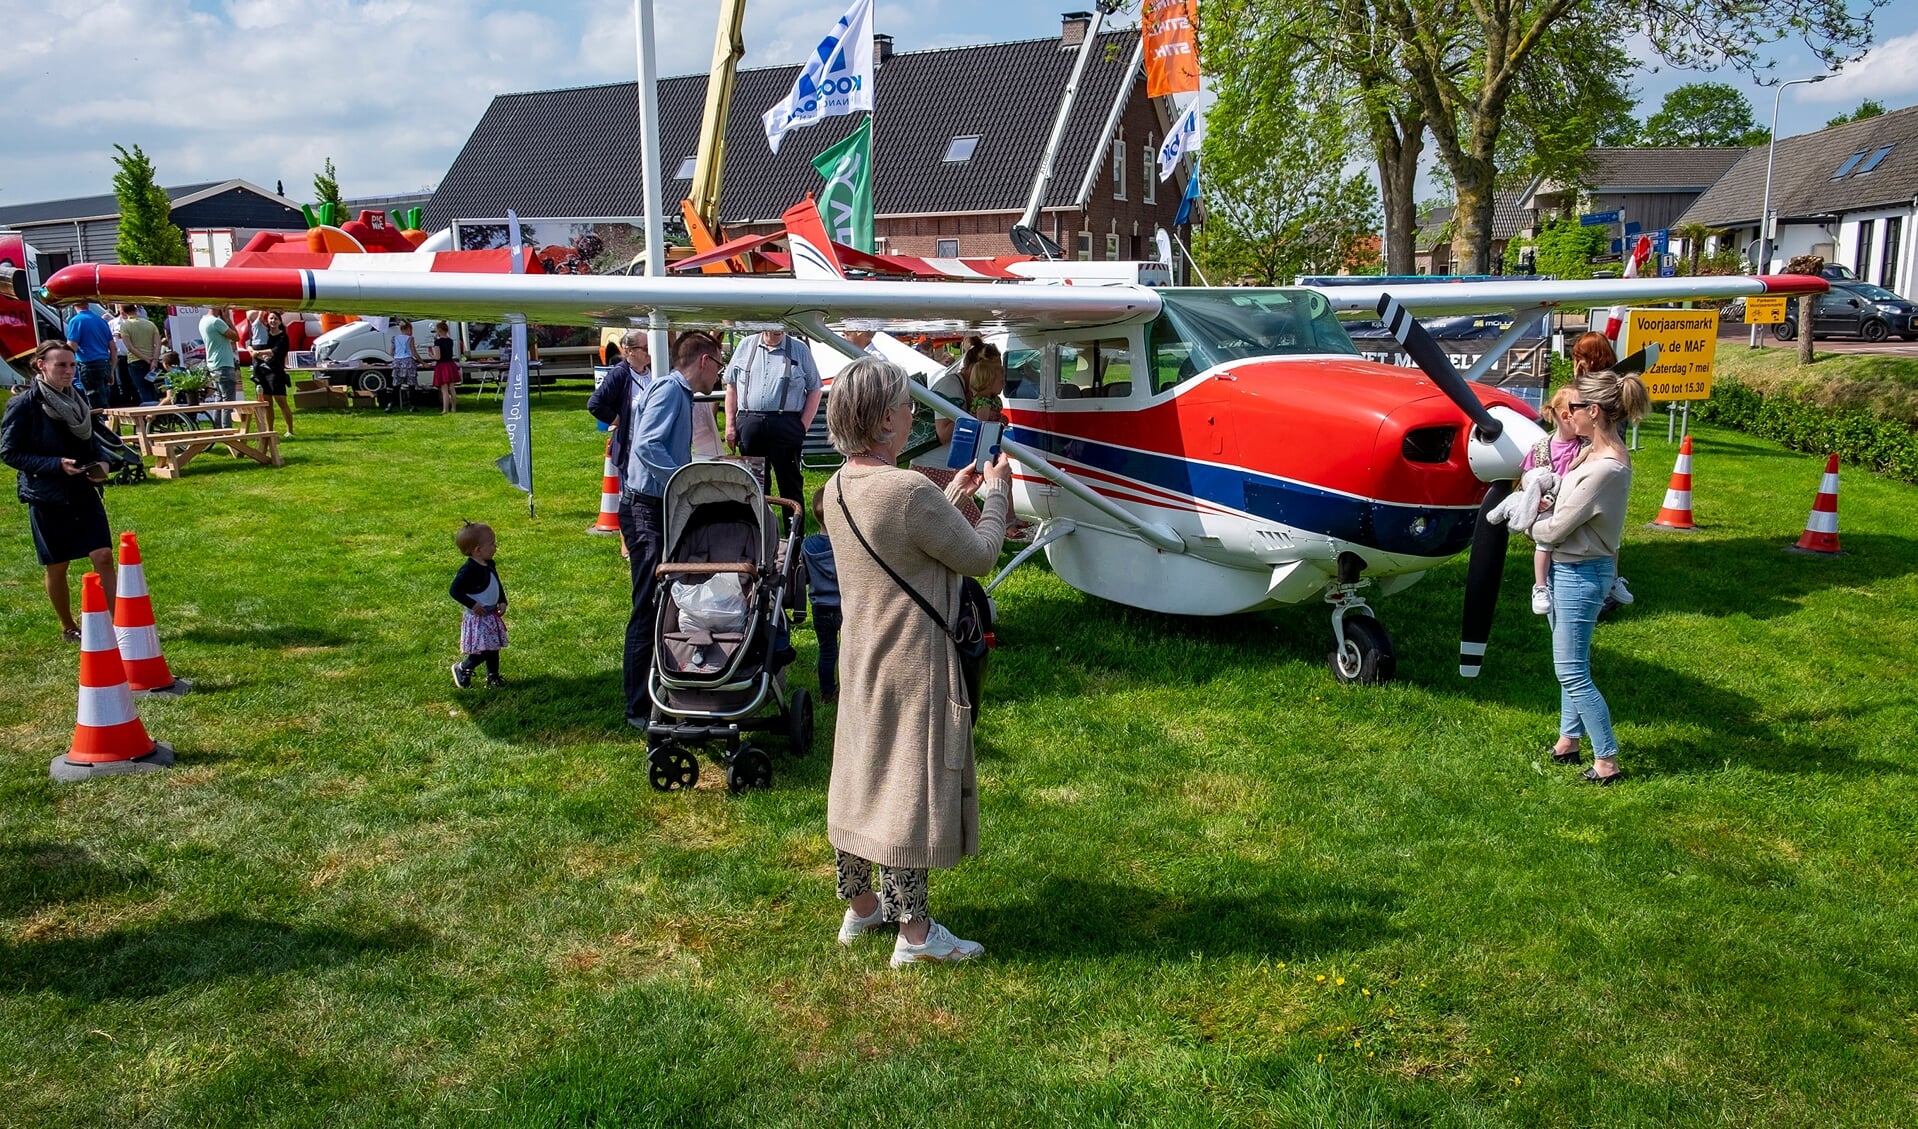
left=0, top=393, right=1918, bottom=1129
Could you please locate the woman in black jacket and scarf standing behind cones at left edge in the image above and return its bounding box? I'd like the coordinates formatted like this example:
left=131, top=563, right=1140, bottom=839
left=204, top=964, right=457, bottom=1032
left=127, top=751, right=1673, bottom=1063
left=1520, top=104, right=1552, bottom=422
left=0, top=341, right=113, bottom=642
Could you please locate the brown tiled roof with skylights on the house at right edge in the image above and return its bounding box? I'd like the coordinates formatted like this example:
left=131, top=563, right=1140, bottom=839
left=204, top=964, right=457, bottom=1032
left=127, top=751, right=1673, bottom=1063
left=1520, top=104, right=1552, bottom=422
left=1678, top=105, right=1918, bottom=228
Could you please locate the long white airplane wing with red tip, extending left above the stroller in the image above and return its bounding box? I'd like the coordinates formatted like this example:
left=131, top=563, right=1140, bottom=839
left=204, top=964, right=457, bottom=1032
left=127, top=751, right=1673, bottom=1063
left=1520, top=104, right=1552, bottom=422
left=44, top=264, right=1160, bottom=334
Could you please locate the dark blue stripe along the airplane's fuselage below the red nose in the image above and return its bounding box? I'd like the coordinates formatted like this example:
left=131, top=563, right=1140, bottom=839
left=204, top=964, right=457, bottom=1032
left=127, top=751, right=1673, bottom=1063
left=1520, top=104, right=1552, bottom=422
left=1011, top=427, right=1479, bottom=558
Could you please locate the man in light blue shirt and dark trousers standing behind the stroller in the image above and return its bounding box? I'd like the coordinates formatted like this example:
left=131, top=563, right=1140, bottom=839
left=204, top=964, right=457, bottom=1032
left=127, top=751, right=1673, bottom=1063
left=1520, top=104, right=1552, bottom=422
left=620, top=334, right=723, bottom=728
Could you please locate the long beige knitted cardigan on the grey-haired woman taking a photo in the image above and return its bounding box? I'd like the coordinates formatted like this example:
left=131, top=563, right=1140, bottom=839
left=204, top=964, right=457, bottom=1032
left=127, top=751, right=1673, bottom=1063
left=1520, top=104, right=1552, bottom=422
left=825, top=464, right=1011, bottom=868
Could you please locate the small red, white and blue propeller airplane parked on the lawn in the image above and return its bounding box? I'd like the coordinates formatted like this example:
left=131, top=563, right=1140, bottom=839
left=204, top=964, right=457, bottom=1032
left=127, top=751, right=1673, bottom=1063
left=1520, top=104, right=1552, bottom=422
left=33, top=234, right=1826, bottom=682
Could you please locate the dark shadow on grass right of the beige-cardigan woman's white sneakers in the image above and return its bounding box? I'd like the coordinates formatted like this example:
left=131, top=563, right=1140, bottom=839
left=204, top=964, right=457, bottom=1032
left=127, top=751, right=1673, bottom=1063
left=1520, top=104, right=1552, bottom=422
left=974, top=878, right=1398, bottom=960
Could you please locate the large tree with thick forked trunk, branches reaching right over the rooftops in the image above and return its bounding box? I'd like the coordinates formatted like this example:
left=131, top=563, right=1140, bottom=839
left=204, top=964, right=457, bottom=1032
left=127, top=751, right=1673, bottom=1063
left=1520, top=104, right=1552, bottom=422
left=1377, top=0, right=1885, bottom=272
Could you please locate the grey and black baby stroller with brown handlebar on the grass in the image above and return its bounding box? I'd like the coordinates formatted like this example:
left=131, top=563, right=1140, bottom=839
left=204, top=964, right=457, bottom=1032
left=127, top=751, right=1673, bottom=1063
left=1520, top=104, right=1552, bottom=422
left=646, top=460, right=813, bottom=792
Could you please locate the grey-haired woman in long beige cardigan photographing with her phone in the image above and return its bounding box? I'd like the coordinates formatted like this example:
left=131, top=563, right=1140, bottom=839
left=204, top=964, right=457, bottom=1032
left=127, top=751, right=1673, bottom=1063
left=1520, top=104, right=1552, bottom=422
left=825, top=357, right=1013, bottom=968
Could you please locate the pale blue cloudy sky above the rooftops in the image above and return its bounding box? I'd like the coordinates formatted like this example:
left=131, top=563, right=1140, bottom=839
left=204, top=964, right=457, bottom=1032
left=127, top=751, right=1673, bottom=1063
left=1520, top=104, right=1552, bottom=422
left=0, top=0, right=1918, bottom=205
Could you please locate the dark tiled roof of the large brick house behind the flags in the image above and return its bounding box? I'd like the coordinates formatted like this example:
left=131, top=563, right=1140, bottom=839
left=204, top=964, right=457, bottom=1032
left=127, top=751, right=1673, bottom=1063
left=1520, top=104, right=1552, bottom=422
left=426, top=31, right=1143, bottom=228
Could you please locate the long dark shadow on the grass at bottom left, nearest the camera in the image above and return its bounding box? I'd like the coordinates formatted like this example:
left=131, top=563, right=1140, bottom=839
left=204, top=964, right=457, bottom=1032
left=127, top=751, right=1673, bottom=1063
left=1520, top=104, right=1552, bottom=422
left=0, top=912, right=432, bottom=1001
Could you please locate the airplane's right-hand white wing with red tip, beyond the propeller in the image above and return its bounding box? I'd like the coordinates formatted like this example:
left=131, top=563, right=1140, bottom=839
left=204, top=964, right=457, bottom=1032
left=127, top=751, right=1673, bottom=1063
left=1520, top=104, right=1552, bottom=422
left=1312, top=274, right=1828, bottom=318
